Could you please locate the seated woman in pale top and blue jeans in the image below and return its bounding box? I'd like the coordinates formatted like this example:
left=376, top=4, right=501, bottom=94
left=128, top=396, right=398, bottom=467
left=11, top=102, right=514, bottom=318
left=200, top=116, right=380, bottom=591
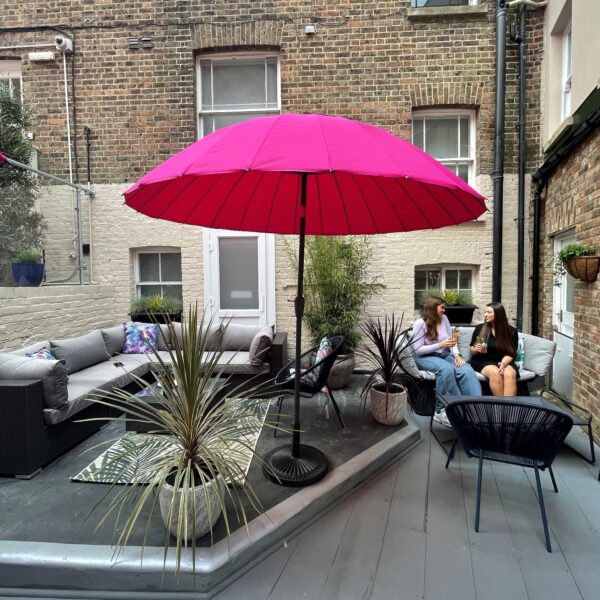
left=412, top=297, right=481, bottom=396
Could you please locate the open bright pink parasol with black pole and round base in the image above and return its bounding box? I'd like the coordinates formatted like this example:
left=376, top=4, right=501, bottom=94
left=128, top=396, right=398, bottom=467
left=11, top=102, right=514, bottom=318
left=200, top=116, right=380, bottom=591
left=125, top=113, right=486, bottom=486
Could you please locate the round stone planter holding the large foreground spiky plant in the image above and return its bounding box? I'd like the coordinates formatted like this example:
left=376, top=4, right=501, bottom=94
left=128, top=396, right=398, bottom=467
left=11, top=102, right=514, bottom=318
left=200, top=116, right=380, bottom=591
left=158, top=477, right=224, bottom=541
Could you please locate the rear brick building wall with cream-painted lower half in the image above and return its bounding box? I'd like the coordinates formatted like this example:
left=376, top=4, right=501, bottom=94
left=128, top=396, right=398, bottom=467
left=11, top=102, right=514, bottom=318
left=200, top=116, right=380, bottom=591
left=0, top=0, right=543, bottom=358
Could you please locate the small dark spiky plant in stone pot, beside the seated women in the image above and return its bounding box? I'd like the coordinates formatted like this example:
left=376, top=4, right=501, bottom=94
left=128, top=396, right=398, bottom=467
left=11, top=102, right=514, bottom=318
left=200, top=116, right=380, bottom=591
left=358, top=313, right=407, bottom=426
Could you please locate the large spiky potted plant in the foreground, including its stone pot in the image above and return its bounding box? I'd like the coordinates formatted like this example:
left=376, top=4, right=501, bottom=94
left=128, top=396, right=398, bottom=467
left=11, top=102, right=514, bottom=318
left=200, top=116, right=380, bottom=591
left=88, top=308, right=266, bottom=573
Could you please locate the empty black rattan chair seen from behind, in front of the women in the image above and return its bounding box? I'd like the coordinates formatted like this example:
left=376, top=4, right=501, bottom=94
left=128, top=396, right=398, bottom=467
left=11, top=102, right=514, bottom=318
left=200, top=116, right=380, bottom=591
left=446, top=398, right=573, bottom=552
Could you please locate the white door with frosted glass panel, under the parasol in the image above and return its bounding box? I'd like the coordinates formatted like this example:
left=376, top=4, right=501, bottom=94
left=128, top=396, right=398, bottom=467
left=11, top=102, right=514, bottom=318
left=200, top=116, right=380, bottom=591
left=203, top=229, right=275, bottom=325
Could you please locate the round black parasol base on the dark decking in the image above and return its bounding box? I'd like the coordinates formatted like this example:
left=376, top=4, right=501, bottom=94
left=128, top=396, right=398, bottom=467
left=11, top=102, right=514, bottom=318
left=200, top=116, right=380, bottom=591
left=263, top=444, right=329, bottom=487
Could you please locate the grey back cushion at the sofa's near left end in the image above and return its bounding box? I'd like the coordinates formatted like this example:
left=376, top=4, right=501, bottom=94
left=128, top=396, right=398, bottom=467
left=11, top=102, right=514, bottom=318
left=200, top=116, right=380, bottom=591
left=0, top=353, right=68, bottom=408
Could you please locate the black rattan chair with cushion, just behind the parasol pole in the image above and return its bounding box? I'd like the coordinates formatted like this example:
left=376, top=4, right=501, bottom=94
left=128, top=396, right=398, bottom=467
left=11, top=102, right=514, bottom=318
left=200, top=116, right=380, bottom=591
left=273, top=335, right=344, bottom=437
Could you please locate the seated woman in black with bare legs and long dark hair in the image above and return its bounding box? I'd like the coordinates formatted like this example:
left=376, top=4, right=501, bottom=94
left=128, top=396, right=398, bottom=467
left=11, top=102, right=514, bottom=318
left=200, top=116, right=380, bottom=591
left=471, top=302, right=519, bottom=396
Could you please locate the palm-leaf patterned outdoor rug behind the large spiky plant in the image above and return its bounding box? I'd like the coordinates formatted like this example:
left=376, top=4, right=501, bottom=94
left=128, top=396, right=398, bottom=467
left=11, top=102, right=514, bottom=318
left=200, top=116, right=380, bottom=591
left=71, top=402, right=269, bottom=485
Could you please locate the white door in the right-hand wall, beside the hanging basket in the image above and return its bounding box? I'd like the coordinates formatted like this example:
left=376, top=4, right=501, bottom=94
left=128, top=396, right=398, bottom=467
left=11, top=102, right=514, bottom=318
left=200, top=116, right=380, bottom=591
left=552, top=233, right=576, bottom=399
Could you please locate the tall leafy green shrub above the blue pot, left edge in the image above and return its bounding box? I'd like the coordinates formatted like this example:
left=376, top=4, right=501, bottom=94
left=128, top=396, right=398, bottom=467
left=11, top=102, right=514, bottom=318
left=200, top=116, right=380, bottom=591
left=0, top=84, right=47, bottom=285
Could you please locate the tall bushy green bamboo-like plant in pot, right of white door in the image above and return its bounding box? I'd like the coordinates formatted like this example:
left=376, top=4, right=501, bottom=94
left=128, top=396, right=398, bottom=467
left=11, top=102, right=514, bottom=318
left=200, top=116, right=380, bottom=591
left=289, top=236, right=379, bottom=390
